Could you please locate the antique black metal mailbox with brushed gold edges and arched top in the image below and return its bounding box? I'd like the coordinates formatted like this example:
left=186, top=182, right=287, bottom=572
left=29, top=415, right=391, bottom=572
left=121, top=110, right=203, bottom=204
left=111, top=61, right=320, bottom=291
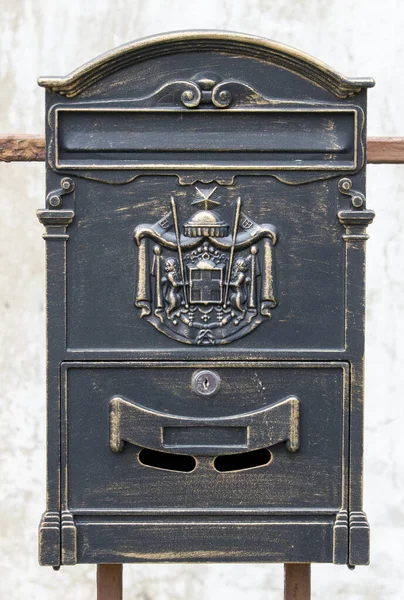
left=38, top=31, right=374, bottom=567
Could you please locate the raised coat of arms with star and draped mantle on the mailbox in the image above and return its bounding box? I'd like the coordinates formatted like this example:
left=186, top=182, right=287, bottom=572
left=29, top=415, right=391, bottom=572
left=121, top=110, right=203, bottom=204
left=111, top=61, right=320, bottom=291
left=134, top=187, right=277, bottom=345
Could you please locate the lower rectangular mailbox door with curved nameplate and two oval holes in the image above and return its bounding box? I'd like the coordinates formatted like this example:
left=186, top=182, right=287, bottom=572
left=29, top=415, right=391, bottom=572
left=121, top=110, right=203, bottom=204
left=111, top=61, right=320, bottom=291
left=61, top=362, right=349, bottom=514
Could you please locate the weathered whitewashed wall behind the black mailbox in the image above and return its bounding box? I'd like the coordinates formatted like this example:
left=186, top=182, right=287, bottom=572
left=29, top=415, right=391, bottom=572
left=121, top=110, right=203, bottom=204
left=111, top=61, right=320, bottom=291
left=0, top=0, right=404, bottom=600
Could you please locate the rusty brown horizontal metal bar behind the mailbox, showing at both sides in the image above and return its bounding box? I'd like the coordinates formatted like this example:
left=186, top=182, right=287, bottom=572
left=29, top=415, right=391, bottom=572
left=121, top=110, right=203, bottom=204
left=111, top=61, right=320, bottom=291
left=0, top=133, right=404, bottom=165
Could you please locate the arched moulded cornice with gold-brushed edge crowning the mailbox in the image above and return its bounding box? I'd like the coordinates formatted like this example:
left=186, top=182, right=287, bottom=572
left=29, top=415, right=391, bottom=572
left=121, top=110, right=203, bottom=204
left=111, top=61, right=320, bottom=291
left=38, top=30, right=375, bottom=98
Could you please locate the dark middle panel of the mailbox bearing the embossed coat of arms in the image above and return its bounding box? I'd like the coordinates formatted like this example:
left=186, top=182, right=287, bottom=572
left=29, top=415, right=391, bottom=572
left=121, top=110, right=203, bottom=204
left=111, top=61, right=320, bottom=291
left=66, top=175, right=347, bottom=356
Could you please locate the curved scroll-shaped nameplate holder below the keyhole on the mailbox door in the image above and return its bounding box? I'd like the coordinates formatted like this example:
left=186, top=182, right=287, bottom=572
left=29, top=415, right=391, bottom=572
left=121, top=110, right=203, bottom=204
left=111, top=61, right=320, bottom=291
left=110, top=396, right=299, bottom=456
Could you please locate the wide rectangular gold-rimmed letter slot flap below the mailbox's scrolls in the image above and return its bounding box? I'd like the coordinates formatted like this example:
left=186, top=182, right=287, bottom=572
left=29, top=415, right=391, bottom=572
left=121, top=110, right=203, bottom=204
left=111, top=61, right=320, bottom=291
left=54, top=108, right=358, bottom=171
